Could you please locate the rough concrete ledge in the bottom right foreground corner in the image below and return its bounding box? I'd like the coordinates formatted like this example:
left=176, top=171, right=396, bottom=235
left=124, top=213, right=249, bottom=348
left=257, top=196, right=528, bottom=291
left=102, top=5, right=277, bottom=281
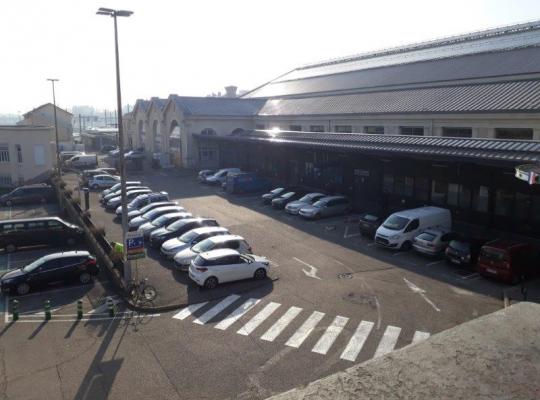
left=271, top=302, right=540, bottom=400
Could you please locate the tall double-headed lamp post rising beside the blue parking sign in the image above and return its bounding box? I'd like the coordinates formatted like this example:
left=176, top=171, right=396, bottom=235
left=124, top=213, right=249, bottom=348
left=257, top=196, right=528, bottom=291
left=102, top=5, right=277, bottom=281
left=96, top=7, right=133, bottom=284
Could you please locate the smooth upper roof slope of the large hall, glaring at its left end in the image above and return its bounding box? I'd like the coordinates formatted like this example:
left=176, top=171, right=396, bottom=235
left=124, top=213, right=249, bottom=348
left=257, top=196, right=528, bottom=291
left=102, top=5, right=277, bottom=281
left=244, top=47, right=540, bottom=98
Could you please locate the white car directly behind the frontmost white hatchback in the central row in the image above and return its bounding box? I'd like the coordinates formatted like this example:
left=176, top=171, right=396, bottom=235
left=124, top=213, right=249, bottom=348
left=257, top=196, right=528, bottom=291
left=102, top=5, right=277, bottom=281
left=174, top=235, right=252, bottom=271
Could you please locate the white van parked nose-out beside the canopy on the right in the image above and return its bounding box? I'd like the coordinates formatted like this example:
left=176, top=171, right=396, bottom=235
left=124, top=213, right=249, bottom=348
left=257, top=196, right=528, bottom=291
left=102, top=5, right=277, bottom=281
left=375, top=207, right=452, bottom=250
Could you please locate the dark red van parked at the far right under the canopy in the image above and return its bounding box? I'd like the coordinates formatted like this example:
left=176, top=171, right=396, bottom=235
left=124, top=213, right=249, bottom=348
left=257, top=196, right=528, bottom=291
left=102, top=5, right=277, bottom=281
left=477, top=239, right=539, bottom=283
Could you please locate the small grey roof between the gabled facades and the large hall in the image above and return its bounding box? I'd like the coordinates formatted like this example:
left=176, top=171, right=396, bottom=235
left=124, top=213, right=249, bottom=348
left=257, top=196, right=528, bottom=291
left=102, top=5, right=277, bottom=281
left=169, top=96, right=265, bottom=117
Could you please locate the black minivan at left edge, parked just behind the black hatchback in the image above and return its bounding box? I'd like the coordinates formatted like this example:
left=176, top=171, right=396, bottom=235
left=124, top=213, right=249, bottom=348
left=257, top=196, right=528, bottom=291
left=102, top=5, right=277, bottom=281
left=0, top=217, right=84, bottom=253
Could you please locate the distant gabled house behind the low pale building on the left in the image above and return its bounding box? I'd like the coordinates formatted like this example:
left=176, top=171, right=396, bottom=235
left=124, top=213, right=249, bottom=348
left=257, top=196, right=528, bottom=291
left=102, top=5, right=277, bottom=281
left=18, top=103, right=73, bottom=144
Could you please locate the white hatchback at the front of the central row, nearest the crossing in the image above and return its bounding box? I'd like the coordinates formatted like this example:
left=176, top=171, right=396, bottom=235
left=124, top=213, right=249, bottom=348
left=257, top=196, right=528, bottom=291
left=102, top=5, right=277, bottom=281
left=189, top=249, right=270, bottom=289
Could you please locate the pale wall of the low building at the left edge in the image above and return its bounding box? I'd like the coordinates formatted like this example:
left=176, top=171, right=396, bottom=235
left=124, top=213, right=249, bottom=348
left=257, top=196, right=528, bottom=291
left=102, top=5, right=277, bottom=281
left=0, top=126, right=56, bottom=186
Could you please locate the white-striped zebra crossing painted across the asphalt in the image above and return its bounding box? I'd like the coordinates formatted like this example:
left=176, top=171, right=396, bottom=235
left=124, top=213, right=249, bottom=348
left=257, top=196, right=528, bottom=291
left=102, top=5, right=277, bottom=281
left=173, top=294, right=430, bottom=362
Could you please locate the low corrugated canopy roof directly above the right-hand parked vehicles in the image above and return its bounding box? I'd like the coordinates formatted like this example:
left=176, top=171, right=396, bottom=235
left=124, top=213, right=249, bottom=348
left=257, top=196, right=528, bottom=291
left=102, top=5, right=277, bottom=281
left=194, top=131, right=540, bottom=163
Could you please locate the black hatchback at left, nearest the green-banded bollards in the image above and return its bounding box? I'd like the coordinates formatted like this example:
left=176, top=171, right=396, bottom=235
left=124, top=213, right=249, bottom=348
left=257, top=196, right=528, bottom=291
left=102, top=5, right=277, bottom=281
left=0, top=251, right=99, bottom=295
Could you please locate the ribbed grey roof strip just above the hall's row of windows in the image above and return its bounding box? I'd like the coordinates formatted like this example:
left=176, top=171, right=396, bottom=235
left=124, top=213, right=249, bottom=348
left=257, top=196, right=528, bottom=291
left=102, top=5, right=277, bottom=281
left=259, top=81, right=540, bottom=116
